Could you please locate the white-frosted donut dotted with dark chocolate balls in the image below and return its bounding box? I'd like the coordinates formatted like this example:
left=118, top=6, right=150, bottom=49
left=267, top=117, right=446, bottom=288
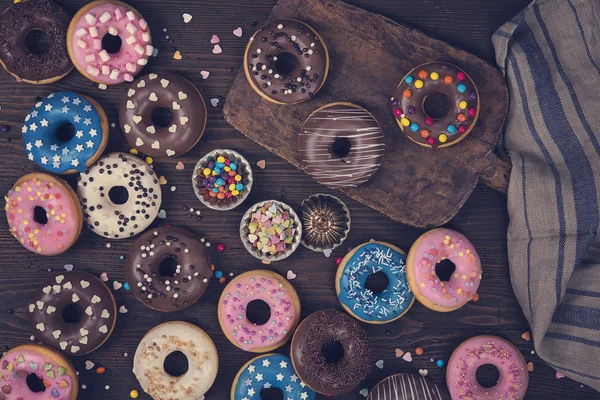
left=77, top=153, right=161, bottom=239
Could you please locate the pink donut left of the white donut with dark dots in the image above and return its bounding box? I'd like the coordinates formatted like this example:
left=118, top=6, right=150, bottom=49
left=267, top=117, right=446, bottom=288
left=5, top=172, right=83, bottom=256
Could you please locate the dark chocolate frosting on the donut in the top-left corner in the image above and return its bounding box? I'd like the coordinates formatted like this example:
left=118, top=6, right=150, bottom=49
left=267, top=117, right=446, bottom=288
left=0, top=0, right=73, bottom=81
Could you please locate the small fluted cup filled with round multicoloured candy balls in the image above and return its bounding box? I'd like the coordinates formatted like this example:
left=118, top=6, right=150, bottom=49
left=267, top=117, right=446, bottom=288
left=192, top=149, right=253, bottom=211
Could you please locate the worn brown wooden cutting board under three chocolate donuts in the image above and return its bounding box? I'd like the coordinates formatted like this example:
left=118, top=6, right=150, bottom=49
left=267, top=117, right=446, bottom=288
left=224, top=0, right=510, bottom=228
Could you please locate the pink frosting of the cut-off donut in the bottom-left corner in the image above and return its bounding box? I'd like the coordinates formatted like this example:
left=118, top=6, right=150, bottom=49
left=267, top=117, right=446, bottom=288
left=0, top=347, right=76, bottom=400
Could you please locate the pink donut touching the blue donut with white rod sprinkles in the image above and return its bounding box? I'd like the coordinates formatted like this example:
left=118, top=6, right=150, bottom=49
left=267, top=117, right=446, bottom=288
left=406, top=228, right=482, bottom=312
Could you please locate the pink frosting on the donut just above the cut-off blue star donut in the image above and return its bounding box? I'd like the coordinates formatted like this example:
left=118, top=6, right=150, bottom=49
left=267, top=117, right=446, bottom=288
left=219, top=273, right=297, bottom=351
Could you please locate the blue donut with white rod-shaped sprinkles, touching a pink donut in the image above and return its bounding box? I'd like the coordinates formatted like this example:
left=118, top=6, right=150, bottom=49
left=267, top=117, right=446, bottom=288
left=335, top=241, right=415, bottom=324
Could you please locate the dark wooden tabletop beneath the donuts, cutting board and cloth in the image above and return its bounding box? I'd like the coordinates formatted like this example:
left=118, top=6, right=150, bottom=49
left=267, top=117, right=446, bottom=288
left=0, top=0, right=598, bottom=400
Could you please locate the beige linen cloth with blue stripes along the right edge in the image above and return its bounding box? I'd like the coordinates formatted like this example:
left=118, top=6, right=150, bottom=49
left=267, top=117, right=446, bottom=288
left=492, top=0, right=600, bottom=390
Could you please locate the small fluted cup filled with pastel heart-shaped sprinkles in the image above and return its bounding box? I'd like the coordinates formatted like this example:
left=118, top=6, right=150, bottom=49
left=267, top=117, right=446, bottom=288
left=240, top=200, right=302, bottom=262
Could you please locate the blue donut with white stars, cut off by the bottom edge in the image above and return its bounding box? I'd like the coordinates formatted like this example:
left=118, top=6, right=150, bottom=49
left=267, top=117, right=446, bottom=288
left=231, top=353, right=316, bottom=400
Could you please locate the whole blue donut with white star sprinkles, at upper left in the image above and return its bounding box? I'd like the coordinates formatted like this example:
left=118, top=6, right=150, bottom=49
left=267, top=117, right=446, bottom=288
left=22, top=92, right=108, bottom=174
